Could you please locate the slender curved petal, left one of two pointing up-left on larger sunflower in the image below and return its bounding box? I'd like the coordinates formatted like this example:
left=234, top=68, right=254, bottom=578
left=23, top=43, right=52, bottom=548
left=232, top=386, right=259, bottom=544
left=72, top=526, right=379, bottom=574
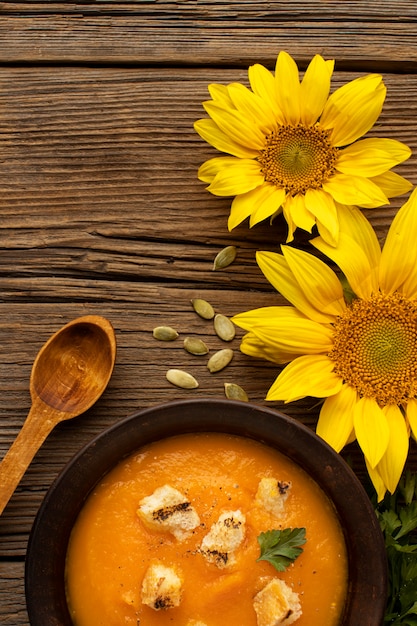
left=256, top=252, right=340, bottom=323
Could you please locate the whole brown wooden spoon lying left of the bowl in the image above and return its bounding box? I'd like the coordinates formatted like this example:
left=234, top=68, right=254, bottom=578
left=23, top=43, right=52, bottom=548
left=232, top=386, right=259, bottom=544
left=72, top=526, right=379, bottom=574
left=0, top=315, right=116, bottom=515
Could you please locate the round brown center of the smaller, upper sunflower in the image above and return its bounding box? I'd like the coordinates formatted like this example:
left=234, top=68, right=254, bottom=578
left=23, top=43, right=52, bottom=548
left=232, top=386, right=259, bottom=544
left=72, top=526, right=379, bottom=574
left=258, top=124, right=338, bottom=195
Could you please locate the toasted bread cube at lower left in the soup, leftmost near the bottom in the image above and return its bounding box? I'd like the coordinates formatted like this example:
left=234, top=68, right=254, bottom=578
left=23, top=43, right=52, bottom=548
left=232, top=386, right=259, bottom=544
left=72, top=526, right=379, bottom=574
left=142, top=563, right=182, bottom=611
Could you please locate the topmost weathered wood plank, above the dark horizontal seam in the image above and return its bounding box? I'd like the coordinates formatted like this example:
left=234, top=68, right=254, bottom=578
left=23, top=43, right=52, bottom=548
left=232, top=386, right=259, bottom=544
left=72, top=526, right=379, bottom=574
left=0, top=11, right=417, bottom=71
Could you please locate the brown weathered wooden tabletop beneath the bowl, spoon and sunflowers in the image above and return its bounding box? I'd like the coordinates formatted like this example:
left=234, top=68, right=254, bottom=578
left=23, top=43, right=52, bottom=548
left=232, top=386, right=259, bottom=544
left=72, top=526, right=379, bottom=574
left=0, top=0, right=417, bottom=626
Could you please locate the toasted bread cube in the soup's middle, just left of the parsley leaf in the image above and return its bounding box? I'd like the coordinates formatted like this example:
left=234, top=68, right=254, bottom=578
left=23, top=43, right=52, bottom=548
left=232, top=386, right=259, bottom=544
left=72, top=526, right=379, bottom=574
left=200, top=510, right=246, bottom=568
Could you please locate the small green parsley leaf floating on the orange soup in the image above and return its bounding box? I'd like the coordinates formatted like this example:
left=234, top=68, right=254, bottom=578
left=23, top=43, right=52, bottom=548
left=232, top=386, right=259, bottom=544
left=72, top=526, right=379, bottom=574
left=256, top=528, right=307, bottom=572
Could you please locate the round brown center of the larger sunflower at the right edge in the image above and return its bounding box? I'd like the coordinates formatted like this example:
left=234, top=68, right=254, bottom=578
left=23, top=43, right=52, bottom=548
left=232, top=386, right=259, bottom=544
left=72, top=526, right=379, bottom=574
left=329, top=293, right=417, bottom=406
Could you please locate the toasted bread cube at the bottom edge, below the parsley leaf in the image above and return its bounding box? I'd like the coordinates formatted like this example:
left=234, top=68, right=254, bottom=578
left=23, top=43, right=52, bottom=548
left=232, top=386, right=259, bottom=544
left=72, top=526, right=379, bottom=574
left=253, top=578, right=302, bottom=626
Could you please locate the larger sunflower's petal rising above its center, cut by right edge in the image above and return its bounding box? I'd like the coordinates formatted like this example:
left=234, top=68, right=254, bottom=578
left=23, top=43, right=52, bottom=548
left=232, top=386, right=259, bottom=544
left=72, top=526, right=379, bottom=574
left=379, top=189, right=417, bottom=293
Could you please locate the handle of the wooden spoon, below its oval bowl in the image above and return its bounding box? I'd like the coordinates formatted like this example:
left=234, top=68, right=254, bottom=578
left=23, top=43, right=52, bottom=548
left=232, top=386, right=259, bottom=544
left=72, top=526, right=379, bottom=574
left=0, top=401, right=60, bottom=515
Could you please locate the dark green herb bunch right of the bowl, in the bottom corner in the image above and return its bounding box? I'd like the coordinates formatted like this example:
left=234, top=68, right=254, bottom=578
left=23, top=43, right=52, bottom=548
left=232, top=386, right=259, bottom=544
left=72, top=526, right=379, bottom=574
left=375, top=471, right=417, bottom=626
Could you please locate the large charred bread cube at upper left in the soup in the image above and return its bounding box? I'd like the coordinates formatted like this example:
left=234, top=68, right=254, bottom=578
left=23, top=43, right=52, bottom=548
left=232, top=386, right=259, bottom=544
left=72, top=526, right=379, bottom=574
left=137, top=485, right=200, bottom=541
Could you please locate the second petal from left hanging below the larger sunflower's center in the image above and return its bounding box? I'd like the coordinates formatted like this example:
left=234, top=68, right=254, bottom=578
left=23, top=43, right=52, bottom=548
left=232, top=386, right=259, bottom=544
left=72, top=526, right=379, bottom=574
left=353, top=397, right=390, bottom=468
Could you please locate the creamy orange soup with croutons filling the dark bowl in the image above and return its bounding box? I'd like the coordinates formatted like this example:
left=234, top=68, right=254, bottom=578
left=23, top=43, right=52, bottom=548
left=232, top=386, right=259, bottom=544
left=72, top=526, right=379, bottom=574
left=66, top=433, right=348, bottom=626
